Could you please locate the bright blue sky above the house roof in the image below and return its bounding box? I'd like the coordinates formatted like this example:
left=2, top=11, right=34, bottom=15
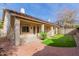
left=0, top=3, right=79, bottom=22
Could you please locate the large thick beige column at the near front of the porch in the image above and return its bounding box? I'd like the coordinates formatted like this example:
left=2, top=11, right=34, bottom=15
left=14, top=18, right=20, bottom=46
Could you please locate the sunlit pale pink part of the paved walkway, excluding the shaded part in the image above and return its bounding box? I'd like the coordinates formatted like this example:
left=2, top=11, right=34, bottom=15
left=13, top=41, right=45, bottom=56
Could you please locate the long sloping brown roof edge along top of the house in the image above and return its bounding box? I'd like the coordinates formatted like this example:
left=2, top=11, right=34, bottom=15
left=3, top=9, right=59, bottom=27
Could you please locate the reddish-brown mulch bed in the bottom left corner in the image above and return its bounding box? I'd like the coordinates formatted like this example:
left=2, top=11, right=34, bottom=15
left=0, top=38, right=15, bottom=56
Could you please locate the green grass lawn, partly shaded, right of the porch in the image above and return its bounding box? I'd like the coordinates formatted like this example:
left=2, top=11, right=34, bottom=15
left=43, top=34, right=76, bottom=47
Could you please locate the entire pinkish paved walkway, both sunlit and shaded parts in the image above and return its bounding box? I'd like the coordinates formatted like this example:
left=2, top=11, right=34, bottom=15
left=11, top=41, right=79, bottom=56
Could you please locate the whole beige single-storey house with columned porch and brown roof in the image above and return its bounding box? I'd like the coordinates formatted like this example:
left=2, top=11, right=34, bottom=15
left=3, top=9, right=59, bottom=45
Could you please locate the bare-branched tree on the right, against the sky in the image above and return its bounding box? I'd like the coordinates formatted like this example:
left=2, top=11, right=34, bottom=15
left=57, top=9, right=76, bottom=33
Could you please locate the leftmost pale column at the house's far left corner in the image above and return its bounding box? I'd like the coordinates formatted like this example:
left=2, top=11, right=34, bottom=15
left=3, top=12, right=10, bottom=36
